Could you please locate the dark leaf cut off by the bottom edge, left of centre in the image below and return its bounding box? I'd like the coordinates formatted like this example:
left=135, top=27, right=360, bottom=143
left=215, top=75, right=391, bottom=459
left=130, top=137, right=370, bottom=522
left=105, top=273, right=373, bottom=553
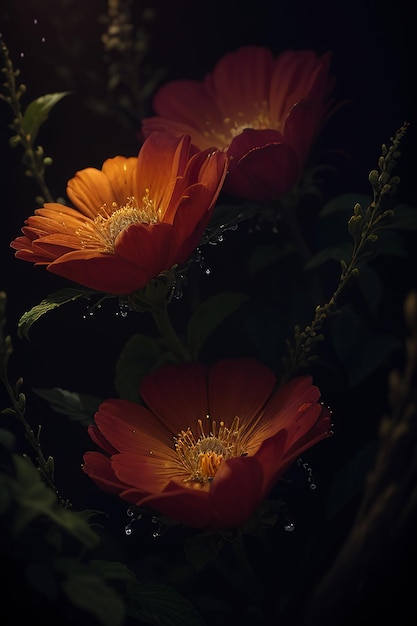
left=129, top=583, right=204, bottom=626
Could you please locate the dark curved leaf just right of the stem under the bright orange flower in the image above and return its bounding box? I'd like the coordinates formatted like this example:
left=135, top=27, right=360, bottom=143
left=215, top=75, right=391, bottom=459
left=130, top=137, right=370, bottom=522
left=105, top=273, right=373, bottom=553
left=187, top=291, right=248, bottom=358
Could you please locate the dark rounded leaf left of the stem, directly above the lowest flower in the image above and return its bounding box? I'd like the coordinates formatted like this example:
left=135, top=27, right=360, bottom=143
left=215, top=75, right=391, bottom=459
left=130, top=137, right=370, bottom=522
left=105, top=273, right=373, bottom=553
left=115, top=334, right=164, bottom=402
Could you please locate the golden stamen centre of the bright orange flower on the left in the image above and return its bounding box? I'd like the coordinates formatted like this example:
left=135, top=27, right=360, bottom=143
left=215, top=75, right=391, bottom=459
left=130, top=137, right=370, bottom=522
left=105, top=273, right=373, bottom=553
left=76, top=189, right=161, bottom=253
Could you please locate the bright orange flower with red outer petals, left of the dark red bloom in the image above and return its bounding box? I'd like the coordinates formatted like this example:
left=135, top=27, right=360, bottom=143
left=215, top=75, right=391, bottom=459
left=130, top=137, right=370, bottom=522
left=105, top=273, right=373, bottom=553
left=11, top=133, right=227, bottom=294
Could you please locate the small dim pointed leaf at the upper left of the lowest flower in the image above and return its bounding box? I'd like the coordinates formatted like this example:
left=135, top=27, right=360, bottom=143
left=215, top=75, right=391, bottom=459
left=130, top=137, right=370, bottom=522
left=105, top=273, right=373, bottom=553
left=33, top=387, right=102, bottom=426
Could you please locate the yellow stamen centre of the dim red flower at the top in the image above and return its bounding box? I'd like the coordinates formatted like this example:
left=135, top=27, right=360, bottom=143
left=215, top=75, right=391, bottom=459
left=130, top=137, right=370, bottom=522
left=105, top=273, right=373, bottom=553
left=204, top=100, right=281, bottom=148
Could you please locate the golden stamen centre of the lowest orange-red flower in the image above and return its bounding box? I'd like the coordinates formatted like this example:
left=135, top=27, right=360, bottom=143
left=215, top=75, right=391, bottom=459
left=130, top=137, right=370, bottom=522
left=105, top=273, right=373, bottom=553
left=175, top=415, right=246, bottom=483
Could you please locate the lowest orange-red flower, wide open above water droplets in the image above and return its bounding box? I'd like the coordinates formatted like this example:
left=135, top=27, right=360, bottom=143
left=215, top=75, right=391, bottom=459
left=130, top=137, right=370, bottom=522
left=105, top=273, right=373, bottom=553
left=83, top=359, right=331, bottom=529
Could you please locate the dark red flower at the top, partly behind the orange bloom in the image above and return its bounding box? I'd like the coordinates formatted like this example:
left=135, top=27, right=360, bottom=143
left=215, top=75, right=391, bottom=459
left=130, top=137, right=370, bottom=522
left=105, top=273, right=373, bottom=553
left=142, top=46, right=334, bottom=202
